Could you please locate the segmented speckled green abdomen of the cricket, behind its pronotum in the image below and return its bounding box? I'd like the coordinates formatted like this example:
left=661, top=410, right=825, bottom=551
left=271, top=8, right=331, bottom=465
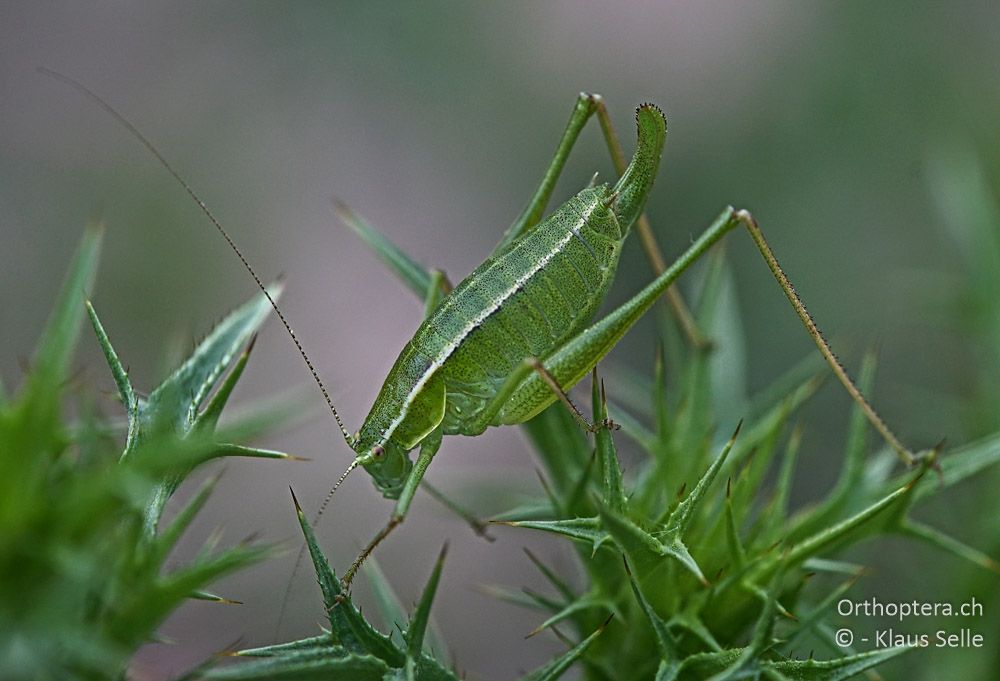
left=434, top=183, right=621, bottom=435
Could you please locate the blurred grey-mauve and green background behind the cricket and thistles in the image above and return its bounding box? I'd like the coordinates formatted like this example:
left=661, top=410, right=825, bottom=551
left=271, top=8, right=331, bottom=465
left=0, top=2, right=1000, bottom=679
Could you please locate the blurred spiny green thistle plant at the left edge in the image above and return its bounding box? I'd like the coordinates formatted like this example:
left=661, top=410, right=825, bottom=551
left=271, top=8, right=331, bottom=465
left=0, top=225, right=296, bottom=680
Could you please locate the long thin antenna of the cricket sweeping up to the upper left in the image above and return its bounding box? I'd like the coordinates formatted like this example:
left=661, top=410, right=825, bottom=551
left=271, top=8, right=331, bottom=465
left=38, top=66, right=354, bottom=449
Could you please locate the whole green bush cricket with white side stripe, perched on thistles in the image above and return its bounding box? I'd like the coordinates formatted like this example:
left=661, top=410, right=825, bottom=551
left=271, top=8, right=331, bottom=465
left=46, top=70, right=915, bottom=604
